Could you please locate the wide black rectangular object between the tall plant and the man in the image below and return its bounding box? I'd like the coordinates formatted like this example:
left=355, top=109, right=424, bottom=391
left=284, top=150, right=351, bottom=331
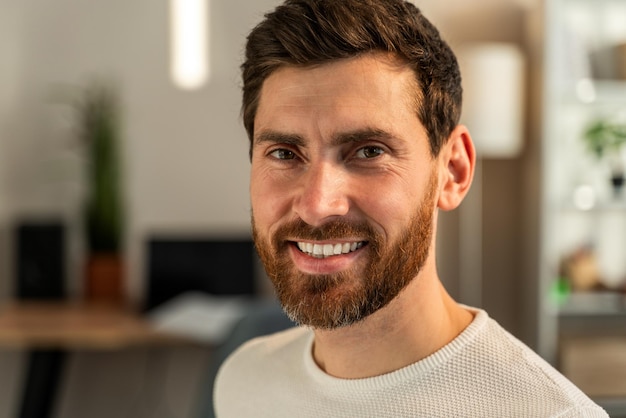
left=145, top=237, right=258, bottom=310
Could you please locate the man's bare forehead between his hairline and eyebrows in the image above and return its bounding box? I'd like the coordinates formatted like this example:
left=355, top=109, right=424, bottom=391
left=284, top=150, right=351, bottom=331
left=255, top=53, right=423, bottom=144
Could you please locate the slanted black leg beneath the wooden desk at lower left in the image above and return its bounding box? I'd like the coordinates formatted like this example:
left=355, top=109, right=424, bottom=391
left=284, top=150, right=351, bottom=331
left=19, top=350, right=66, bottom=418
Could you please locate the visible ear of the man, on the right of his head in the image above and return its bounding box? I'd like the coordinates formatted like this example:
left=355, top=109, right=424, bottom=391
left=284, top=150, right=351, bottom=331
left=437, top=125, right=476, bottom=210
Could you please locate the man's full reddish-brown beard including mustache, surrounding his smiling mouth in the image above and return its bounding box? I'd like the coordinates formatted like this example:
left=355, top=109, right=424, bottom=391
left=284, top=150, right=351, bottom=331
left=252, top=172, right=437, bottom=329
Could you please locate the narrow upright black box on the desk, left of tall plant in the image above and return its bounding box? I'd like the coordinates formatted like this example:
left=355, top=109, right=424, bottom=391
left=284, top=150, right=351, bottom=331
left=14, top=221, right=65, bottom=300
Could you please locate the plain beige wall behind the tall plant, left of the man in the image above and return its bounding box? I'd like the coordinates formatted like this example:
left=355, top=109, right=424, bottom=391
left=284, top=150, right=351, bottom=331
left=0, top=0, right=276, bottom=300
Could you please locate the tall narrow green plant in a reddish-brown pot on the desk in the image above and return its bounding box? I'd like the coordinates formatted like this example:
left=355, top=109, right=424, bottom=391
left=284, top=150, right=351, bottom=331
left=78, top=82, right=125, bottom=304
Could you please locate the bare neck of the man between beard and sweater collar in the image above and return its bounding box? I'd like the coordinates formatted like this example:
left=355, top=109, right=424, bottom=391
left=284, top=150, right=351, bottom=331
left=313, top=268, right=472, bottom=379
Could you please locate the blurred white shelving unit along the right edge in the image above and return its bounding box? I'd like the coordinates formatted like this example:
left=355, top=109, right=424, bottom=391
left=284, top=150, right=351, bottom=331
left=538, top=0, right=626, bottom=416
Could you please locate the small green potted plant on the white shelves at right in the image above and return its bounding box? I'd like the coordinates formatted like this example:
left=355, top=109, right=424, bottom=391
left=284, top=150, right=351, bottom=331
left=583, top=119, right=626, bottom=195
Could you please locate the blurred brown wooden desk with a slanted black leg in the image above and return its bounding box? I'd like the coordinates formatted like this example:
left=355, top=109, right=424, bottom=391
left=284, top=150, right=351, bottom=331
left=0, top=302, right=185, bottom=418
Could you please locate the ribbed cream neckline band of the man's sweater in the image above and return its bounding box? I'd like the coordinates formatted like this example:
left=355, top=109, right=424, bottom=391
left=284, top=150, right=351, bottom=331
left=303, top=306, right=489, bottom=390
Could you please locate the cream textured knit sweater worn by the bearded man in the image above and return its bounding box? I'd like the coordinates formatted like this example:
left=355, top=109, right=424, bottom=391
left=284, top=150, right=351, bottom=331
left=215, top=310, right=608, bottom=418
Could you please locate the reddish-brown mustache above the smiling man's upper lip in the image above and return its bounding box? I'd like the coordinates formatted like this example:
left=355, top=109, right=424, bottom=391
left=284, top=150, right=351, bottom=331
left=274, top=219, right=380, bottom=245
